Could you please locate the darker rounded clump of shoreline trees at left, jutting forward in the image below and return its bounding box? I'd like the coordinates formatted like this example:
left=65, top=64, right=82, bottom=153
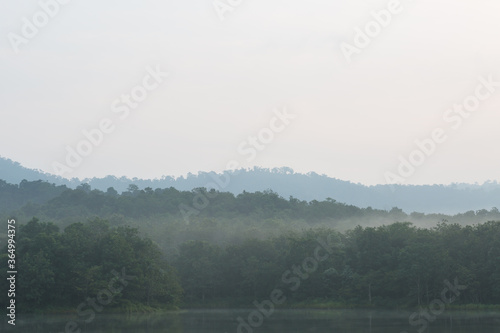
left=0, top=219, right=182, bottom=312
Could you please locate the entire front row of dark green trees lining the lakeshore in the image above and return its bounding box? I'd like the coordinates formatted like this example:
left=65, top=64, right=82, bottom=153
left=0, top=219, right=500, bottom=314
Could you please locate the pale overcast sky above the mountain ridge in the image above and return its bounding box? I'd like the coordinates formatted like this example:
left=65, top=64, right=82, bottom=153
left=0, top=0, right=500, bottom=185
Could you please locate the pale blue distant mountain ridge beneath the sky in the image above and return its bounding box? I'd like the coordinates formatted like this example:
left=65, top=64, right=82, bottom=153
left=0, top=158, right=500, bottom=214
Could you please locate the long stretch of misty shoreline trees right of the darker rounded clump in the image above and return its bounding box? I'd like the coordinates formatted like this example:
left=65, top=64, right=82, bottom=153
left=175, top=222, right=500, bottom=307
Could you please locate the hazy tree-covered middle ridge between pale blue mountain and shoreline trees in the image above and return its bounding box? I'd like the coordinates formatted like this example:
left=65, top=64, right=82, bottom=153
left=5, top=181, right=500, bottom=224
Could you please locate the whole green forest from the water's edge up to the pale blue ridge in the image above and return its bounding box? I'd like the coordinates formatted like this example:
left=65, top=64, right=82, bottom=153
left=0, top=182, right=500, bottom=313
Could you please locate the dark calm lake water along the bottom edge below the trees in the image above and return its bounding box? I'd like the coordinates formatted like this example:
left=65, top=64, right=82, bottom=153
left=2, top=309, right=500, bottom=333
